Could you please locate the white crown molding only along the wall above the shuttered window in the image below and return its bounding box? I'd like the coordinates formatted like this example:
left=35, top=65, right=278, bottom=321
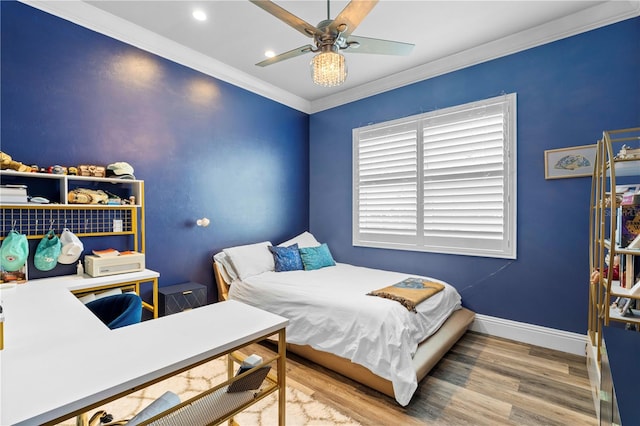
left=310, top=0, right=640, bottom=114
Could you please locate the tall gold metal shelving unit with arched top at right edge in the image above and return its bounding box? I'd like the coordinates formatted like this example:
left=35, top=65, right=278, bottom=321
left=587, top=127, right=640, bottom=422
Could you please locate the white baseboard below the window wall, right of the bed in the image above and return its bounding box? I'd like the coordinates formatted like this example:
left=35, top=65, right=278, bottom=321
left=470, top=314, right=587, bottom=356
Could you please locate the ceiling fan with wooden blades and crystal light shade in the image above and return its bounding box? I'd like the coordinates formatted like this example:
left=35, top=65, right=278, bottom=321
left=249, top=0, right=414, bottom=87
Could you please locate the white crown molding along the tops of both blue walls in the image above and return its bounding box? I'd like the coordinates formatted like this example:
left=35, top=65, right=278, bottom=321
left=20, top=0, right=640, bottom=114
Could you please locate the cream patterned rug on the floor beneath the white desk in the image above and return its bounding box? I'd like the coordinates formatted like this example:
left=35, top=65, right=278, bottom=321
left=60, top=359, right=361, bottom=426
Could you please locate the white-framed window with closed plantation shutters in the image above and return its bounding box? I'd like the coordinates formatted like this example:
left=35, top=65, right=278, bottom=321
left=353, top=94, right=516, bottom=259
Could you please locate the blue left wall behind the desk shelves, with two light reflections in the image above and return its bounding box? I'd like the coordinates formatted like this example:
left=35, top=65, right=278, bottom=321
left=0, top=1, right=309, bottom=300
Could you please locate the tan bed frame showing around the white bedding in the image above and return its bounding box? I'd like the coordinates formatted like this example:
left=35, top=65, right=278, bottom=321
left=213, top=261, right=475, bottom=398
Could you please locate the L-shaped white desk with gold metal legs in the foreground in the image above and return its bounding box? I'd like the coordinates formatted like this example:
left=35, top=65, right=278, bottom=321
left=0, top=277, right=288, bottom=425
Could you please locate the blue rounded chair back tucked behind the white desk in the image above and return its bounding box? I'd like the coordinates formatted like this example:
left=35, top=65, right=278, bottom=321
left=85, top=293, right=142, bottom=330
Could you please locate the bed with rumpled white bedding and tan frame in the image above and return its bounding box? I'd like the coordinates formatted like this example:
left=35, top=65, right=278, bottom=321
left=213, top=232, right=475, bottom=406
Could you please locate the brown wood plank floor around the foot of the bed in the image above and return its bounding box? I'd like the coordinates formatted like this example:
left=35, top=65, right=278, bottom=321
left=250, top=332, right=596, bottom=426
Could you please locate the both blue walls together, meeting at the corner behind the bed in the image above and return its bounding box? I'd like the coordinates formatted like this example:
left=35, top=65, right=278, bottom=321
left=0, top=2, right=640, bottom=333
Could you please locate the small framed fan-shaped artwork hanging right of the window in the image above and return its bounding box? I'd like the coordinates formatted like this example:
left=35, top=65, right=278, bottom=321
left=544, top=144, right=597, bottom=179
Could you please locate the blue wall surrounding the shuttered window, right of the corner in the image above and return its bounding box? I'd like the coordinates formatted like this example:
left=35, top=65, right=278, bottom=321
left=310, top=18, right=640, bottom=334
